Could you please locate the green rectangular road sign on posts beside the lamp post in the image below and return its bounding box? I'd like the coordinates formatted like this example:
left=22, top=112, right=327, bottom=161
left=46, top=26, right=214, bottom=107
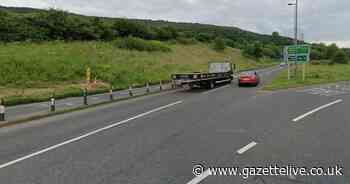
left=285, top=45, right=310, bottom=64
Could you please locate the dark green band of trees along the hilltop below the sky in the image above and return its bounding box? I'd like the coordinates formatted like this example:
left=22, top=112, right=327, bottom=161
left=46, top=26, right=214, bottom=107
left=0, top=7, right=350, bottom=60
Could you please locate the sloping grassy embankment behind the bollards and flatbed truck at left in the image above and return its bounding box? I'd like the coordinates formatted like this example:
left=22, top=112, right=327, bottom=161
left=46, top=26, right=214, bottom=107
left=0, top=42, right=271, bottom=104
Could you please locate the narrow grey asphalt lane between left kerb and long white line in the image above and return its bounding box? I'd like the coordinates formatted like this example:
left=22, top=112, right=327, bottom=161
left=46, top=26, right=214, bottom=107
left=0, top=89, right=193, bottom=162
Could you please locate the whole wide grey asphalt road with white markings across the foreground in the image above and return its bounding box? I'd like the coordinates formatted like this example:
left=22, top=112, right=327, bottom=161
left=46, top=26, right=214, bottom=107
left=0, top=68, right=350, bottom=184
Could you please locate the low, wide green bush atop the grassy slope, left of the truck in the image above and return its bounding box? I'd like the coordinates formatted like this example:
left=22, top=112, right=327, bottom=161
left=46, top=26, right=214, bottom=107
left=115, top=37, right=171, bottom=52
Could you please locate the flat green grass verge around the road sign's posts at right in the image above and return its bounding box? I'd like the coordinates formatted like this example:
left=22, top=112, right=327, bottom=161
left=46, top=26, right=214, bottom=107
left=263, top=64, right=350, bottom=90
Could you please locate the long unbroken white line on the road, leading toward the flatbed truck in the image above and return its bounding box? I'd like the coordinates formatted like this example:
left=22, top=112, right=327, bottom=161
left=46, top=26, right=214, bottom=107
left=0, top=101, right=183, bottom=169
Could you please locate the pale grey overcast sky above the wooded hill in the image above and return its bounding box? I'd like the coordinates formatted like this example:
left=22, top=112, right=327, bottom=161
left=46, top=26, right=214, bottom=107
left=0, top=0, right=350, bottom=47
